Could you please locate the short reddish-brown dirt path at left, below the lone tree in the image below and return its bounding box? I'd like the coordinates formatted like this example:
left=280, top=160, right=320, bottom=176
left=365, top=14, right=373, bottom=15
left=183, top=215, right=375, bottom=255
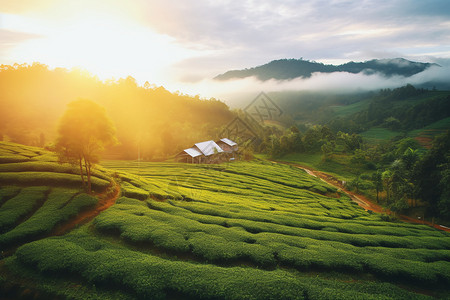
left=50, top=183, right=120, bottom=235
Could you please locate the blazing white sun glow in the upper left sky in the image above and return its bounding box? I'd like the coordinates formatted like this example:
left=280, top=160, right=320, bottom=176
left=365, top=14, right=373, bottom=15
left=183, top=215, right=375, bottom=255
left=2, top=13, right=193, bottom=83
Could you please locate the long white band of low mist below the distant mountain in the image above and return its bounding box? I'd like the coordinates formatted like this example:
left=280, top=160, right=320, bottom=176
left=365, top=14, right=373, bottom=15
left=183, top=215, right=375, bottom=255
left=169, top=59, right=450, bottom=107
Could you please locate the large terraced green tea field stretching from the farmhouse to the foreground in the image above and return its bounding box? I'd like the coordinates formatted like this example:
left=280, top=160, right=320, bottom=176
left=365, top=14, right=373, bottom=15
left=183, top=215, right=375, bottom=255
left=0, top=142, right=450, bottom=299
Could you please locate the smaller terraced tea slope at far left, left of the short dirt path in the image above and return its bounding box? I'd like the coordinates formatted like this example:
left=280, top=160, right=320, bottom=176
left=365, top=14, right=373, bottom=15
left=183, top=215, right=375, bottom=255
left=0, top=142, right=112, bottom=251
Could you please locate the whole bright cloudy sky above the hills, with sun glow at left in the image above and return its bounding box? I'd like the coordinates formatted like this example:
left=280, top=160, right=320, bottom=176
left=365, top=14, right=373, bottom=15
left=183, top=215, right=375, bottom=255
left=0, top=0, right=450, bottom=97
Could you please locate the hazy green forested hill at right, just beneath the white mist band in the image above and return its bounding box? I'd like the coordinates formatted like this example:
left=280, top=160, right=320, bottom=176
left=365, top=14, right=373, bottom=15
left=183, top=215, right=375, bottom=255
left=269, top=84, right=450, bottom=133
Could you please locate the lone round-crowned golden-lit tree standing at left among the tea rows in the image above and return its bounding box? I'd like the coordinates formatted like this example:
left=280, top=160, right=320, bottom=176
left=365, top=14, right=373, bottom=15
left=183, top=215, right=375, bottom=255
left=56, top=99, right=117, bottom=193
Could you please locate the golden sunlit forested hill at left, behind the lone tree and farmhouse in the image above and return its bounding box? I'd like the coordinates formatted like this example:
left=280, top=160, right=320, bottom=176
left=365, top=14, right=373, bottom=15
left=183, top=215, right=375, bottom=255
left=0, top=63, right=233, bottom=159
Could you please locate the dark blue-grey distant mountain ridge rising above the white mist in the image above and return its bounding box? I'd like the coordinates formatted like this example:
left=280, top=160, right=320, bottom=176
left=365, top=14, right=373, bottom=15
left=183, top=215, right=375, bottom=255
left=214, top=58, right=438, bottom=81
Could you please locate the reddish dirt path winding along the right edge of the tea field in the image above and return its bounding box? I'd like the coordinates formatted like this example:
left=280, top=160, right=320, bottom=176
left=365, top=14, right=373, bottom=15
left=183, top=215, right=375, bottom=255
left=272, top=161, right=450, bottom=232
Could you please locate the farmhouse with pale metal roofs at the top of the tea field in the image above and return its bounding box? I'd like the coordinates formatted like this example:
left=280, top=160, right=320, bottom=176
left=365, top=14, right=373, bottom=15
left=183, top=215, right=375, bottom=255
left=175, top=138, right=238, bottom=164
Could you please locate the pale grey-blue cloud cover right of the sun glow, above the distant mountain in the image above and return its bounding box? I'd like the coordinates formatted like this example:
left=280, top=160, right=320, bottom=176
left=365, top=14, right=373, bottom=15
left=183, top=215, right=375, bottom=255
left=137, top=0, right=450, bottom=80
